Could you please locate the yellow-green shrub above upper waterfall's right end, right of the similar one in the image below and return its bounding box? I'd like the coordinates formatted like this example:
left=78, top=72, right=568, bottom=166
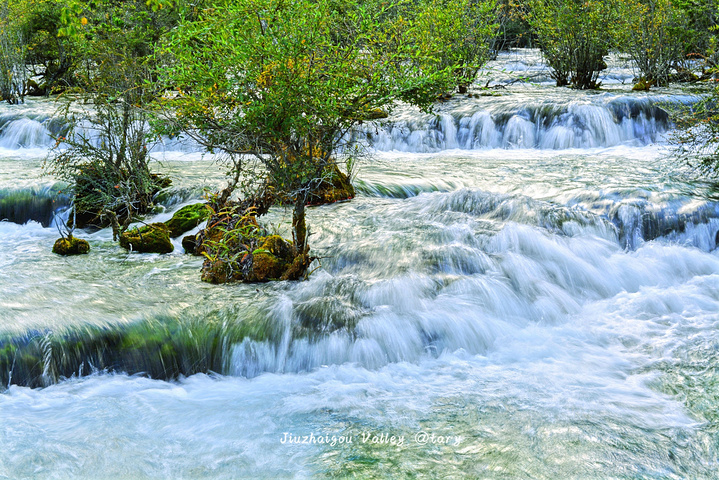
left=618, top=0, right=686, bottom=86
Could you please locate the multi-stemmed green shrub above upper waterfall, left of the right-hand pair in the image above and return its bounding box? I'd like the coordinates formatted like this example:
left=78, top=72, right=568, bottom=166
left=526, top=0, right=618, bottom=89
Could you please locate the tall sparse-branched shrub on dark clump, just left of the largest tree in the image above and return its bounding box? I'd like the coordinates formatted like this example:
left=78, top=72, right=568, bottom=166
left=47, top=1, right=177, bottom=237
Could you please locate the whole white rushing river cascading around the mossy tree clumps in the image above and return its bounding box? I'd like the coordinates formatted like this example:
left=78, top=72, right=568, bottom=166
left=0, top=52, right=719, bottom=479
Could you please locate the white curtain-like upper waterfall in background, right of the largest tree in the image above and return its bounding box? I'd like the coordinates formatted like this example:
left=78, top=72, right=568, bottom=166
left=355, top=96, right=696, bottom=152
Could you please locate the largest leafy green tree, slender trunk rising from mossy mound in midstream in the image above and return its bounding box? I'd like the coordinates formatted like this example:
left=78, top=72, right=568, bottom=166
left=162, top=0, right=461, bottom=270
